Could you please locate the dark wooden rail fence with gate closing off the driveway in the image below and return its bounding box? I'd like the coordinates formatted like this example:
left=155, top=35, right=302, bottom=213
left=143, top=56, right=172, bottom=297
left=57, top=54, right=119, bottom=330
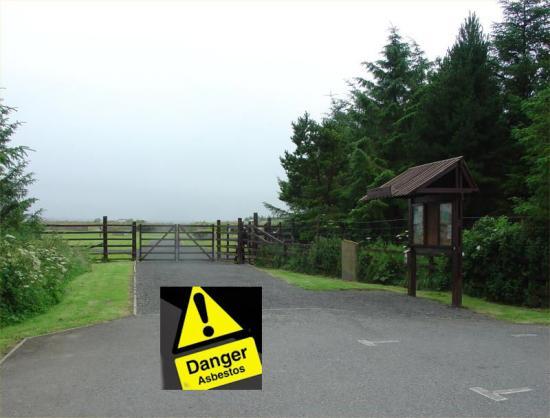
left=43, top=213, right=458, bottom=264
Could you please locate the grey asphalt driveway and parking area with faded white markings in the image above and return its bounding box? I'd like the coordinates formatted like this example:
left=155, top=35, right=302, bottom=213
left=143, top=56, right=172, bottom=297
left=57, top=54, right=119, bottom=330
left=0, top=261, right=550, bottom=416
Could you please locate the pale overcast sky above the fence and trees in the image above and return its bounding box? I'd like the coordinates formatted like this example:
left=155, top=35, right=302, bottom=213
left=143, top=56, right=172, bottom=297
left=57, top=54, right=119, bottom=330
left=0, top=0, right=502, bottom=221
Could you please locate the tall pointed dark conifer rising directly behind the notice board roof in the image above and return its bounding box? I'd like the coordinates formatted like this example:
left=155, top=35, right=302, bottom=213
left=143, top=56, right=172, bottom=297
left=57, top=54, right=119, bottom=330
left=407, top=14, right=511, bottom=215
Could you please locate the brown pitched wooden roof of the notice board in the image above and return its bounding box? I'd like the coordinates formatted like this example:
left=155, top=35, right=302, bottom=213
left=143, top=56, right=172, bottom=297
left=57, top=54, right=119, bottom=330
left=361, top=156, right=479, bottom=201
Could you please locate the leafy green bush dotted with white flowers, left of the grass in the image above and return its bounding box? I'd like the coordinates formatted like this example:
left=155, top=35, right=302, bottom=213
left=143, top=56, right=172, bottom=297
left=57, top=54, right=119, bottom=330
left=0, top=234, right=89, bottom=326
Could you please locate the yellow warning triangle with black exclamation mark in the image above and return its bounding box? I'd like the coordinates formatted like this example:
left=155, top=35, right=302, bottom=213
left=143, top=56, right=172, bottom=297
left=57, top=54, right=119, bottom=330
left=178, top=286, right=242, bottom=348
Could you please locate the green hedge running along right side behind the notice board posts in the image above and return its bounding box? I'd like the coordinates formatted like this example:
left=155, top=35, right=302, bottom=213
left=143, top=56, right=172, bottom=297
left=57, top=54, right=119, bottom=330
left=257, top=217, right=549, bottom=307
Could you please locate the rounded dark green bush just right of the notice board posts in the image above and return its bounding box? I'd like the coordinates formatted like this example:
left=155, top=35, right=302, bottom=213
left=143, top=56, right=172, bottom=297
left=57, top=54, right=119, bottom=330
left=463, top=217, right=549, bottom=307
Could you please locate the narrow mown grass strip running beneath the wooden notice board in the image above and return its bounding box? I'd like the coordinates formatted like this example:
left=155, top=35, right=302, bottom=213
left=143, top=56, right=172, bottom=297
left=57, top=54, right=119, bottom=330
left=260, top=268, right=550, bottom=325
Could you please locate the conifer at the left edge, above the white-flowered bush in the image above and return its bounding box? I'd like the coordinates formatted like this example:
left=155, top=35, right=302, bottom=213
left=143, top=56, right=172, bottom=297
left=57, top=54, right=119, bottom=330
left=0, top=103, right=36, bottom=230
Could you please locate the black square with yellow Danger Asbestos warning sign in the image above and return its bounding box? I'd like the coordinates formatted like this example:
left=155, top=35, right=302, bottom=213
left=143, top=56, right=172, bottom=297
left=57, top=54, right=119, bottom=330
left=161, top=286, right=262, bottom=390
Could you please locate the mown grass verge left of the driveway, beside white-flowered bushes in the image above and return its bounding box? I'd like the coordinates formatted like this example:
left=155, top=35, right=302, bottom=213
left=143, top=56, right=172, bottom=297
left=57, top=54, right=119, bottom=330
left=0, top=262, right=133, bottom=356
